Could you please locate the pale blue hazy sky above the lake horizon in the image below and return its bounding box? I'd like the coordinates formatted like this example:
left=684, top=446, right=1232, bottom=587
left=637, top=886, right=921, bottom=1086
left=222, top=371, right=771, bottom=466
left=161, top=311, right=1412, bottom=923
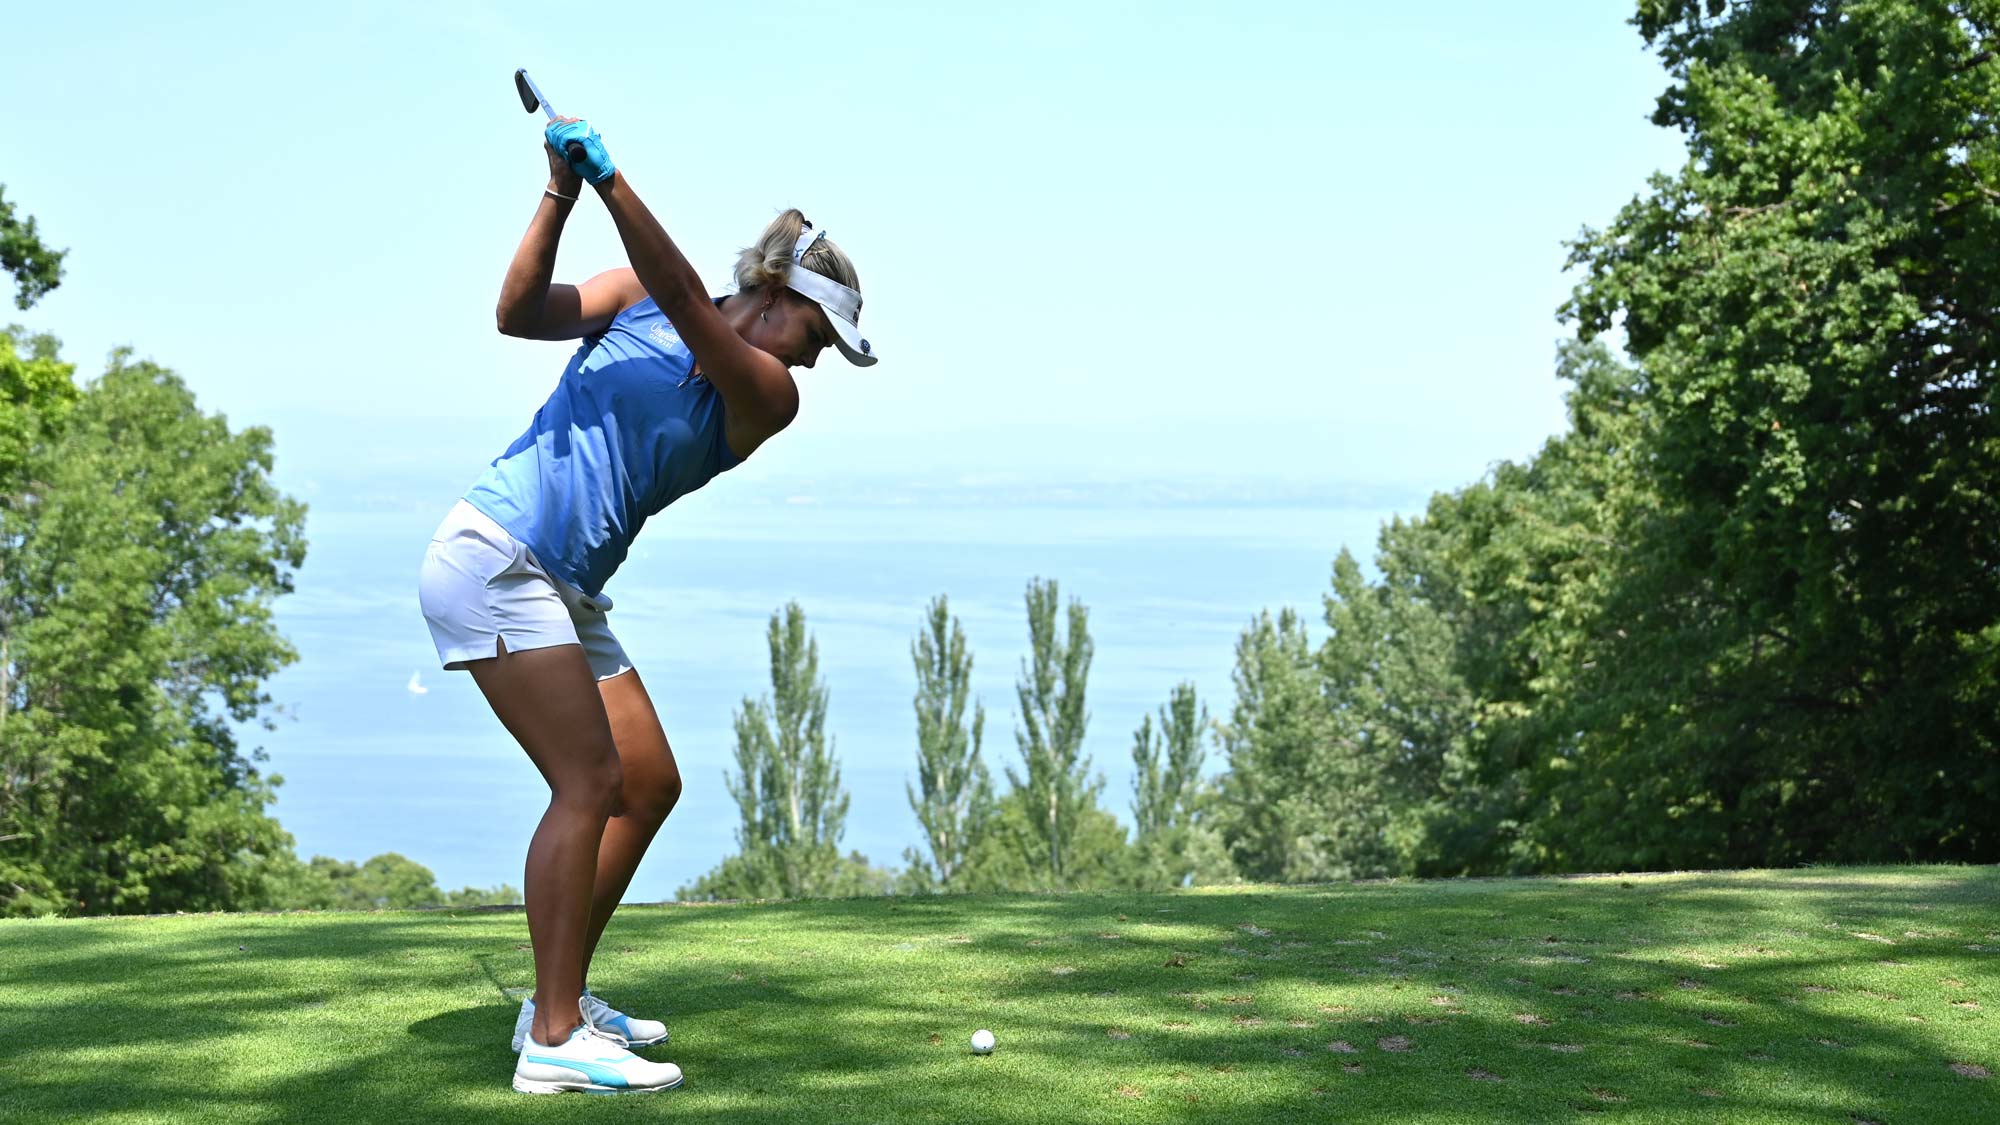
left=0, top=0, right=1680, bottom=498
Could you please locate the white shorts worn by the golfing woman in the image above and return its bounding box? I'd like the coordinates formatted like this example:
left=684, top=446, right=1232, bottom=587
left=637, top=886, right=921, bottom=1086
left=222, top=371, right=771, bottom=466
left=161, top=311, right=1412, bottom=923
left=416, top=500, right=632, bottom=681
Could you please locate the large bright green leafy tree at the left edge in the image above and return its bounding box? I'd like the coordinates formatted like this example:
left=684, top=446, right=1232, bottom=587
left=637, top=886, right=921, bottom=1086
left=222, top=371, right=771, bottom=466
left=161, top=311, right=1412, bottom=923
left=0, top=336, right=306, bottom=913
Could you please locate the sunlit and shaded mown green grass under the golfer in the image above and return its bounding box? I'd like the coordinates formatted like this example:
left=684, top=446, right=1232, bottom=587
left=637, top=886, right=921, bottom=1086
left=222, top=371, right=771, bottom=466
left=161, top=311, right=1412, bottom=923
left=0, top=867, right=2000, bottom=1125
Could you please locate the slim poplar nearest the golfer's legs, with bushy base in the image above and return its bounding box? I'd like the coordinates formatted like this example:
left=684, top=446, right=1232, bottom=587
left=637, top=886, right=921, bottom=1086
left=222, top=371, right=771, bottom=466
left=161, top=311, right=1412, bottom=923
left=680, top=603, right=866, bottom=899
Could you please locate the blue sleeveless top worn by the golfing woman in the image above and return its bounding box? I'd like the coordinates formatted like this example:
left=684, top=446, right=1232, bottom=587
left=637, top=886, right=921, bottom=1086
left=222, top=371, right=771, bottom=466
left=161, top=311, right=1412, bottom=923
left=466, top=296, right=742, bottom=597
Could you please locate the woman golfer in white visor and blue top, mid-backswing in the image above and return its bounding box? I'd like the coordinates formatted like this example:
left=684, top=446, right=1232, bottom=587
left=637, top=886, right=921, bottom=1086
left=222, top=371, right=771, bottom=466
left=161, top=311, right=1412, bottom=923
left=420, top=118, right=876, bottom=1093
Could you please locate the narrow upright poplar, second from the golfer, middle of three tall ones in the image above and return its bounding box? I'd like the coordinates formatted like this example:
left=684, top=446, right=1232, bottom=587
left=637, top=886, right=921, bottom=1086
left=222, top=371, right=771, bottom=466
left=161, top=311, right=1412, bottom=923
left=904, top=595, right=994, bottom=889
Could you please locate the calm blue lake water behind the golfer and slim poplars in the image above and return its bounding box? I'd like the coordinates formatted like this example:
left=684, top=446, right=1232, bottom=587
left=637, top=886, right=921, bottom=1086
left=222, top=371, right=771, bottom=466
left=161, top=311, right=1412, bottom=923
left=244, top=476, right=1414, bottom=901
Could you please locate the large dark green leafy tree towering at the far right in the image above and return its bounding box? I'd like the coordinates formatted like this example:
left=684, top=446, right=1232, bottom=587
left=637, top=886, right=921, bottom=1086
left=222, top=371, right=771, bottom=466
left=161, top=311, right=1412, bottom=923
left=1538, top=0, right=2000, bottom=867
